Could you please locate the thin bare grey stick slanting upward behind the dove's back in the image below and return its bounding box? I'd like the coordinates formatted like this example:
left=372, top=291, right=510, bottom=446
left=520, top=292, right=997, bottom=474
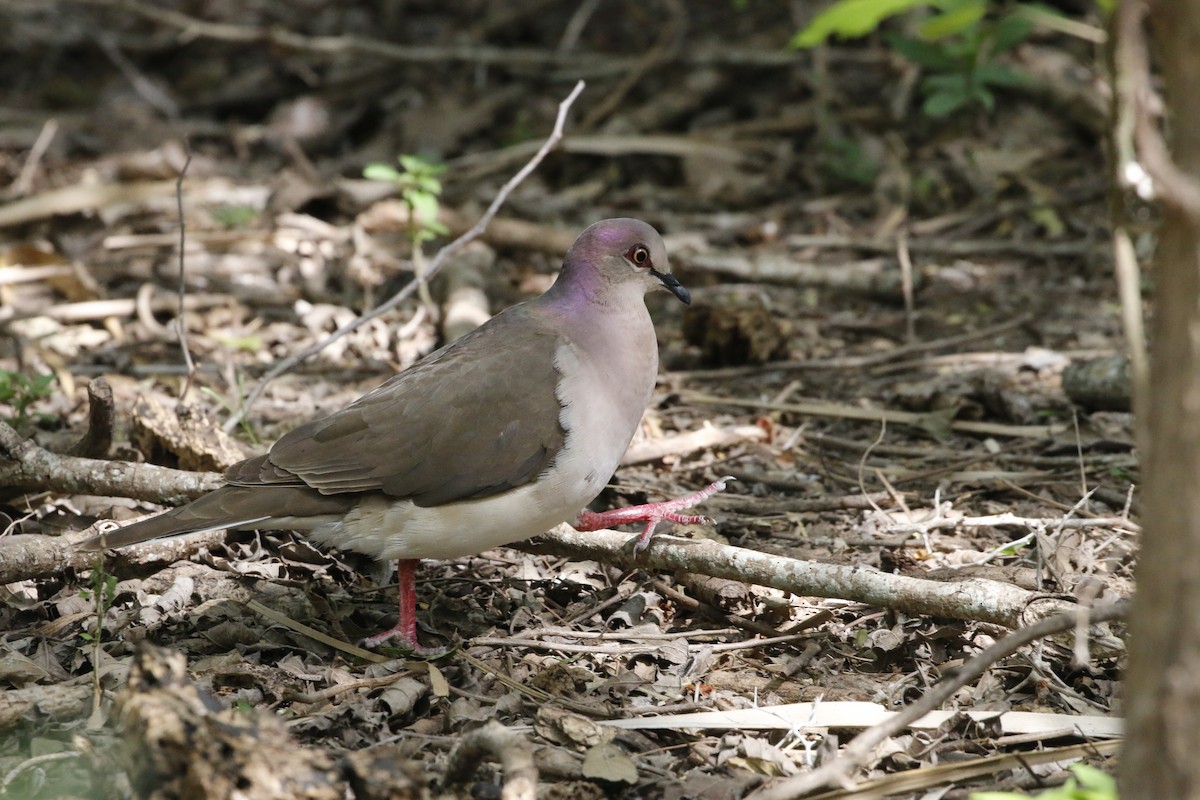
left=224, top=80, right=584, bottom=432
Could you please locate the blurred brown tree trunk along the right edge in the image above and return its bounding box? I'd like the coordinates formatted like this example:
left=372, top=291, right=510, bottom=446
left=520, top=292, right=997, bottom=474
left=1121, top=0, right=1200, bottom=800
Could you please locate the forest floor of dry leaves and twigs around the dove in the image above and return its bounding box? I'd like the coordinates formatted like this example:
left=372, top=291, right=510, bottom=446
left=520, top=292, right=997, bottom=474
left=0, top=0, right=1141, bottom=800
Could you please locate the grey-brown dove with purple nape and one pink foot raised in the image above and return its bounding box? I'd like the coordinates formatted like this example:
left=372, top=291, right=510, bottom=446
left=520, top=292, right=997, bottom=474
left=84, top=219, right=719, bottom=652
